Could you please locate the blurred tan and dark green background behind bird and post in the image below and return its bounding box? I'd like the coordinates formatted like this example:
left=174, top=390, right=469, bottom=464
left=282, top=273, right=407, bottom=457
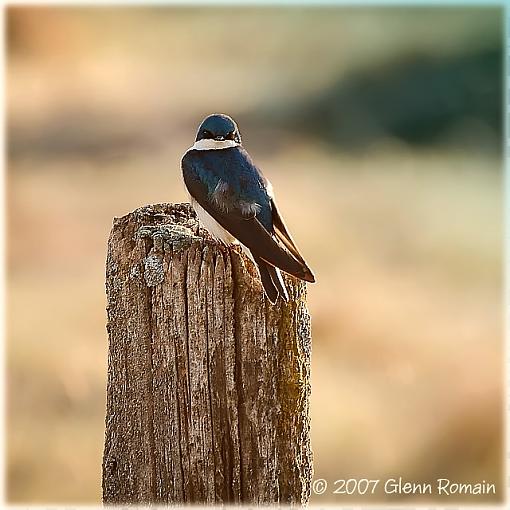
left=6, top=6, right=503, bottom=504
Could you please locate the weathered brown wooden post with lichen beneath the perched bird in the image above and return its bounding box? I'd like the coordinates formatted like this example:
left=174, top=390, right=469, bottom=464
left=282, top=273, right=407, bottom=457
left=103, top=204, right=312, bottom=504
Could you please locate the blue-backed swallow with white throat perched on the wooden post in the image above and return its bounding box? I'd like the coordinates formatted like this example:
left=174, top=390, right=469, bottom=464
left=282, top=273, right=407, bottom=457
left=181, top=114, right=315, bottom=303
